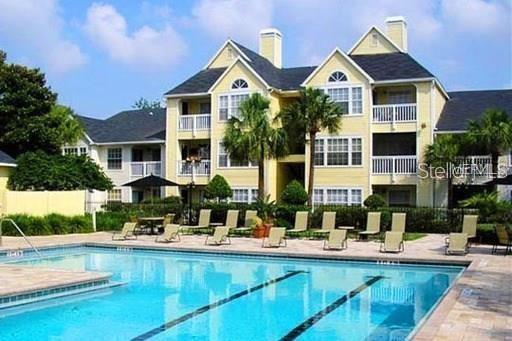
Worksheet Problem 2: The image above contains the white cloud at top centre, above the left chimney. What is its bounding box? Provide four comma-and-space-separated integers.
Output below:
192, 0, 273, 44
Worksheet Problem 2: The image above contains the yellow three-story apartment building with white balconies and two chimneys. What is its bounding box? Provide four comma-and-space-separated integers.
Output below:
164, 17, 512, 206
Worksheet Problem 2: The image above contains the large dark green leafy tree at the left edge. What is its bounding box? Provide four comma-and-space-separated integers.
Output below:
0, 51, 83, 156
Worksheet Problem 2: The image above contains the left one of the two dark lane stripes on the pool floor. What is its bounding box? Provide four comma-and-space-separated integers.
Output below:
132, 270, 306, 341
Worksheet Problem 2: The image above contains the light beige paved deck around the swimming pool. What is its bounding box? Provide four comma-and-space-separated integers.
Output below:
0, 232, 512, 341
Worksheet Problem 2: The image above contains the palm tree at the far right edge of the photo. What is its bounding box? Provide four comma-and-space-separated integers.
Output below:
468, 109, 512, 179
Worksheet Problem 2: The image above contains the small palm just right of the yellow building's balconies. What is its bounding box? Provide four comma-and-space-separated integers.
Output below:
425, 135, 460, 208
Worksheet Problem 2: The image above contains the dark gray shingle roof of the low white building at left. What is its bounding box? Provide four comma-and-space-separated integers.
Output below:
78, 108, 166, 143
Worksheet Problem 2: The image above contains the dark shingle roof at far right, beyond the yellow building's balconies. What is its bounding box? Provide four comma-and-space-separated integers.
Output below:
436, 89, 512, 131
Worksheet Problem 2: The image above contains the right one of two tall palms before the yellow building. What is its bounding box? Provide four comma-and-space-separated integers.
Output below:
278, 88, 343, 205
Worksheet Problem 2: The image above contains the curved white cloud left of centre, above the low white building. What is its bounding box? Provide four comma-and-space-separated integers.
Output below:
84, 3, 187, 69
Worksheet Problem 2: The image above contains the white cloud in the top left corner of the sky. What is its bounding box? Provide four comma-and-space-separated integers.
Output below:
0, 0, 86, 73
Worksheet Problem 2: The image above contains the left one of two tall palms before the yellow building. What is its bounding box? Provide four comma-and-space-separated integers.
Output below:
222, 93, 288, 199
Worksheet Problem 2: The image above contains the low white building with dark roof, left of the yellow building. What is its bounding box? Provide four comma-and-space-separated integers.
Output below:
66, 108, 166, 206
